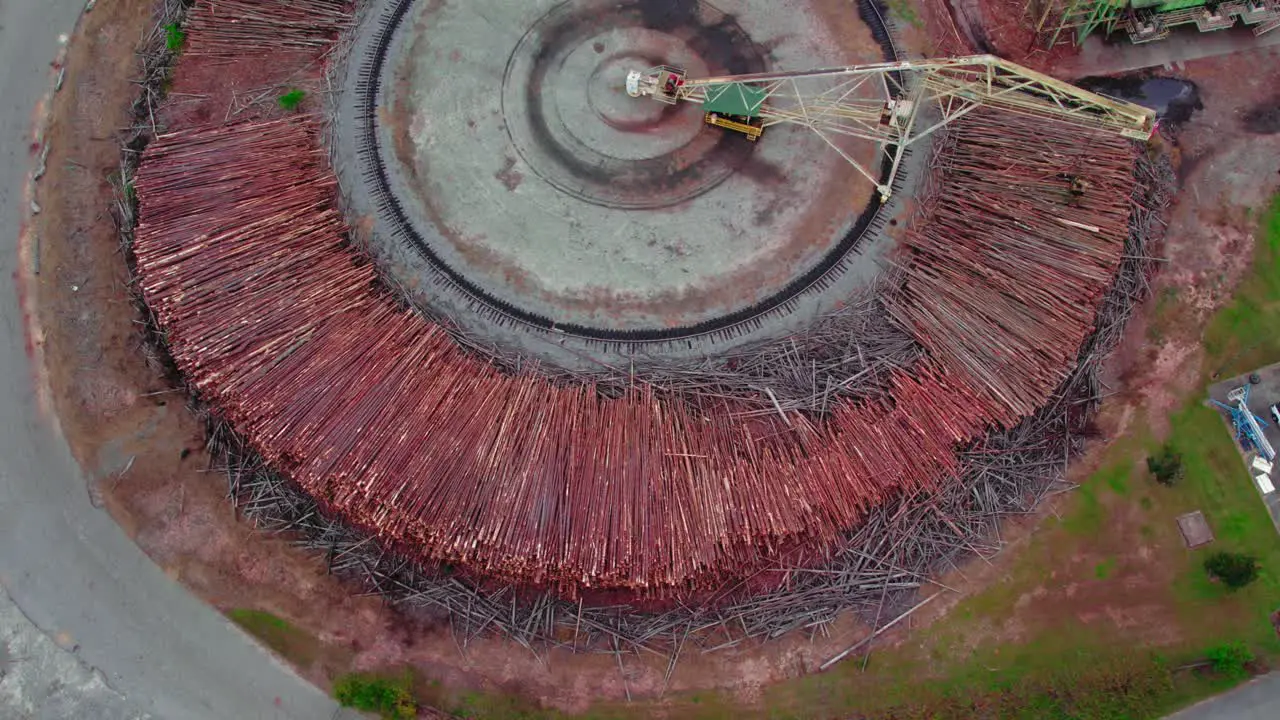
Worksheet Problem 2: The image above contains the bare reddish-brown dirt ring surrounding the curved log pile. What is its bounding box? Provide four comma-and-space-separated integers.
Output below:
27, 0, 1280, 710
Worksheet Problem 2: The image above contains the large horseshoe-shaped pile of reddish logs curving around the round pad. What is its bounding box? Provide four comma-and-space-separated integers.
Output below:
127, 113, 1133, 597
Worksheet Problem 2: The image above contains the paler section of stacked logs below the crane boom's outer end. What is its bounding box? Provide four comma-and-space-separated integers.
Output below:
888, 111, 1134, 427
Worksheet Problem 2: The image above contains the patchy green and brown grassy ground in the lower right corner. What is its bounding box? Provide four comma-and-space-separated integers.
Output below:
373, 197, 1280, 720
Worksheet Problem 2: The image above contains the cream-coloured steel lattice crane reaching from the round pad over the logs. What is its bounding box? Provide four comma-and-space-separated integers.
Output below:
627, 55, 1156, 199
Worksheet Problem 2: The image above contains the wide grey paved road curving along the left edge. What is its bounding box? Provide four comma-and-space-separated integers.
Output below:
0, 0, 337, 720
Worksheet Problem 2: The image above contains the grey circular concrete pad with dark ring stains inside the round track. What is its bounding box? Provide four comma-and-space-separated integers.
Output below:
345, 0, 883, 334
